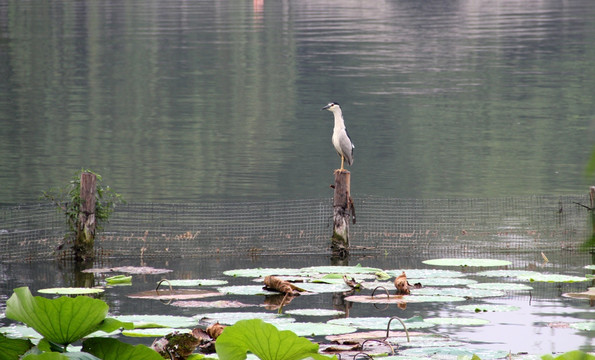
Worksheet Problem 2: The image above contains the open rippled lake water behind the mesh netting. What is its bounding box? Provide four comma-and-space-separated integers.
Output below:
0, 0, 595, 203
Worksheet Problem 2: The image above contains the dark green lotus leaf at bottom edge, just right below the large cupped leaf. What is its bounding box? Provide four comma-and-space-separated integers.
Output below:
83, 338, 163, 360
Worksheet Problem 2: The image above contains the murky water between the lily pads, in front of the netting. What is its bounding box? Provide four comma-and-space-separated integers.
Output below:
0, 252, 595, 355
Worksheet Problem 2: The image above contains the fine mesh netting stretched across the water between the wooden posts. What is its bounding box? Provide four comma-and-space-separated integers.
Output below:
0, 195, 592, 260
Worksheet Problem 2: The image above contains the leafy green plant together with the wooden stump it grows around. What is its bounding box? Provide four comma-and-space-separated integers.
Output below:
42, 169, 124, 261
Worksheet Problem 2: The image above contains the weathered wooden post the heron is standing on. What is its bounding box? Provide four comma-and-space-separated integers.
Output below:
331, 170, 351, 258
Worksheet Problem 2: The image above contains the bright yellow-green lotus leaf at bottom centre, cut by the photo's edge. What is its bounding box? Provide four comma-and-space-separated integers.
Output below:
215, 319, 336, 360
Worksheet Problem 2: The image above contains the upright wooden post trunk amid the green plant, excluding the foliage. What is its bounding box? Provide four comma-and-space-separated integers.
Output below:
74, 172, 97, 261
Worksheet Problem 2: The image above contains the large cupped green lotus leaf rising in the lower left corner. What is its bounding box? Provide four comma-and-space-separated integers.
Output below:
6, 287, 108, 345
